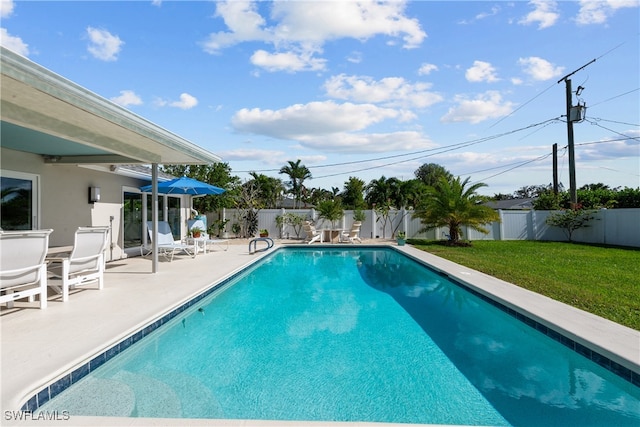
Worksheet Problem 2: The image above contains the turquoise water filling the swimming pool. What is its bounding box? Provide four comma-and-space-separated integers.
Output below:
40, 248, 640, 426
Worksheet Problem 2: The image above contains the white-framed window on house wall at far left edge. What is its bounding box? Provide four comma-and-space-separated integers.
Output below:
0, 170, 40, 230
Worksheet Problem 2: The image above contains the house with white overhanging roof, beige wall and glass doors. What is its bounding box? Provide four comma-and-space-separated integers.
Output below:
0, 47, 221, 260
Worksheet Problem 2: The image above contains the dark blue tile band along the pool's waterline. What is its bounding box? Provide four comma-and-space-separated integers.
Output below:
21, 245, 640, 412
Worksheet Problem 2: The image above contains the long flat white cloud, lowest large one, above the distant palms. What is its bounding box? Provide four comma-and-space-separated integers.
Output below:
231, 101, 404, 140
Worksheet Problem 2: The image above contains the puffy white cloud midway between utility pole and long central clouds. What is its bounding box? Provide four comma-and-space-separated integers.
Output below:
440, 91, 514, 124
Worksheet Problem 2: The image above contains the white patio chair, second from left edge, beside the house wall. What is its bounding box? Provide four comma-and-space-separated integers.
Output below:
48, 227, 109, 302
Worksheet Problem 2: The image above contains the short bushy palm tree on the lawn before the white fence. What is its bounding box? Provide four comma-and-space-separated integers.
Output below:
413, 177, 500, 244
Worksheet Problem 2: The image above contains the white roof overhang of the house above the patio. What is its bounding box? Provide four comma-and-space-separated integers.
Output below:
0, 47, 221, 164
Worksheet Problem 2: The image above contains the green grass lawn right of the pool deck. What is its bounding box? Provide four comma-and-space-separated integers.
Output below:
408, 239, 640, 330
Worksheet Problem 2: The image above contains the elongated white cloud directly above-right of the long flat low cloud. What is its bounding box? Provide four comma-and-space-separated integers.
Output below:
324, 74, 443, 108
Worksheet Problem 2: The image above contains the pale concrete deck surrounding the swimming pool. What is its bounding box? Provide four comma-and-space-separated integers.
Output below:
0, 240, 640, 426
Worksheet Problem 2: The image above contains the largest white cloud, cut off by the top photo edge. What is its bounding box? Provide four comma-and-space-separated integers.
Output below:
203, 0, 426, 71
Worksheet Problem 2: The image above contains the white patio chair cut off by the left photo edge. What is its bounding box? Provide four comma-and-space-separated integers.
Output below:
0, 230, 53, 308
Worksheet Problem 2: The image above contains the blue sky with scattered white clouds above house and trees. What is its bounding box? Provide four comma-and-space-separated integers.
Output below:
0, 0, 640, 195
